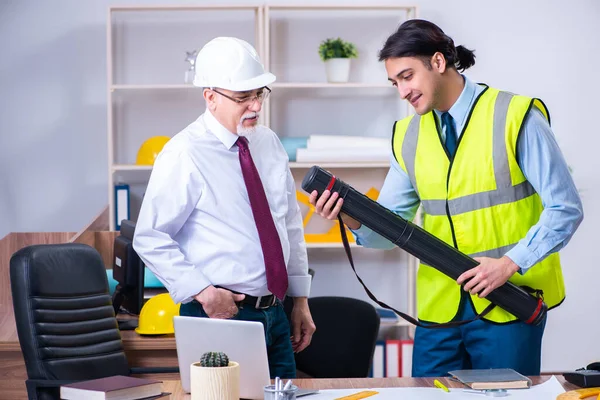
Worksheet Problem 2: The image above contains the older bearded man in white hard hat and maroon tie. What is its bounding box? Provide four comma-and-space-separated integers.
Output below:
134, 37, 315, 378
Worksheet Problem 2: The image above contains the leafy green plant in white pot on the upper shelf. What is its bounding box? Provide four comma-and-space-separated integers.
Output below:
319, 38, 358, 83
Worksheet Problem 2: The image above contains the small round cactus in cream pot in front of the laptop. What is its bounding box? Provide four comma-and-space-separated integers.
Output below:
190, 351, 240, 400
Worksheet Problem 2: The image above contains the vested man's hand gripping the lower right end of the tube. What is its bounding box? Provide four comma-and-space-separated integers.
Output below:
456, 256, 519, 298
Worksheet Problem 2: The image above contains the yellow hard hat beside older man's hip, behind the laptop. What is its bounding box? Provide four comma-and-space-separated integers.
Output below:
135, 293, 181, 335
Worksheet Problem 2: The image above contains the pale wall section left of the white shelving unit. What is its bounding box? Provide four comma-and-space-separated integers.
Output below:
0, 1, 107, 231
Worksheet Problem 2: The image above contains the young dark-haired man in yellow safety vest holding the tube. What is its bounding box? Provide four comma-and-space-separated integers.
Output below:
311, 20, 583, 376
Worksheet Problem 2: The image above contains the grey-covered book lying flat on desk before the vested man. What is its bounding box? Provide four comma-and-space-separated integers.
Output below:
448, 368, 531, 390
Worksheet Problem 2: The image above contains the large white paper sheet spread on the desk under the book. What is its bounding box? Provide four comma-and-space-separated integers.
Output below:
301, 376, 565, 400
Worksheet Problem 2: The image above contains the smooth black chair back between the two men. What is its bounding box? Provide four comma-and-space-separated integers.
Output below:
284, 297, 380, 378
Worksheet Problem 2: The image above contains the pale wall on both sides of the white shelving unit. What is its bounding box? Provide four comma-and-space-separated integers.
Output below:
0, 0, 600, 371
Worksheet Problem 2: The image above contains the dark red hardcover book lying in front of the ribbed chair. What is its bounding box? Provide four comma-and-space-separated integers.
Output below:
60, 375, 162, 400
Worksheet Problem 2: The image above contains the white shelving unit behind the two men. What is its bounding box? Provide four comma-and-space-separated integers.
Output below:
107, 3, 418, 327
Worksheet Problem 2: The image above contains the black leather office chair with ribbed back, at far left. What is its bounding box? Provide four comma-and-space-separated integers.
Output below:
10, 243, 179, 400
